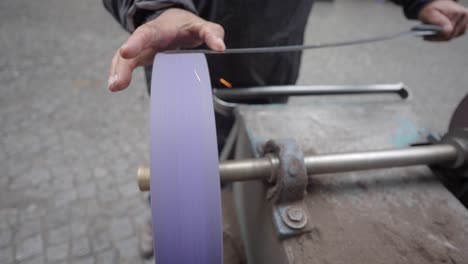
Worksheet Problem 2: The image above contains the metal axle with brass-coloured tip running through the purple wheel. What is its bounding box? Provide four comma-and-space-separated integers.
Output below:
138, 144, 458, 191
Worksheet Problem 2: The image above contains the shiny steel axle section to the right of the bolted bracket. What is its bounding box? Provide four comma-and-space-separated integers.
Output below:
304, 144, 457, 175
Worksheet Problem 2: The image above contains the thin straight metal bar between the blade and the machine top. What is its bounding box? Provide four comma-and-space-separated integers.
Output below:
213, 83, 409, 101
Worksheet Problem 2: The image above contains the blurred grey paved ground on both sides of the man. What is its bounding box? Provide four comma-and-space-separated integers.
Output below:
0, 0, 468, 264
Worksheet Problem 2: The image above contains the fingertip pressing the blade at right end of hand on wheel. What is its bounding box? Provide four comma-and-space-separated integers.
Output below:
195, 22, 226, 51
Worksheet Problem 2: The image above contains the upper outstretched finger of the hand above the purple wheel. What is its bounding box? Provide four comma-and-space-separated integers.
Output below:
120, 24, 158, 59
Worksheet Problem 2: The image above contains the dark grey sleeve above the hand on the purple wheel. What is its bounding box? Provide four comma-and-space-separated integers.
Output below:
103, 0, 197, 32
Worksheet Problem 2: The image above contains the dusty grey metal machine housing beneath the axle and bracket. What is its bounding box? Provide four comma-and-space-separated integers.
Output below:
234, 96, 468, 263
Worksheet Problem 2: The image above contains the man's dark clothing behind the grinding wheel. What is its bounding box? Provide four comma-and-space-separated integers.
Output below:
103, 0, 431, 152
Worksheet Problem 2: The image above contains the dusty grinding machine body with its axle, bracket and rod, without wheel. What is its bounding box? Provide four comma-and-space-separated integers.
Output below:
139, 89, 468, 263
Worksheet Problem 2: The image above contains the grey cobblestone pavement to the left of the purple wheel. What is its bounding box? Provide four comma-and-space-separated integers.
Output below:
0, 0, 149, 264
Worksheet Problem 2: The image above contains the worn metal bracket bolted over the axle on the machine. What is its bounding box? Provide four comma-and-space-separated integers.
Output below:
260, 139, 312, 239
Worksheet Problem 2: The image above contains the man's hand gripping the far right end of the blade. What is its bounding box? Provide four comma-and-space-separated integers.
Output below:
419, 0, 468, 41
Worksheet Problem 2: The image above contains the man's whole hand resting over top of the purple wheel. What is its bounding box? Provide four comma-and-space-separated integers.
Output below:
108, 8, 226, 92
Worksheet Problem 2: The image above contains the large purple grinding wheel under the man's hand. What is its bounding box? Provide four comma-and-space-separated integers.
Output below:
150, 54, 223, 264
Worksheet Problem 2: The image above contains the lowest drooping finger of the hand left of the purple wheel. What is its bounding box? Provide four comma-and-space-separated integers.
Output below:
107, 50, 137, 92
